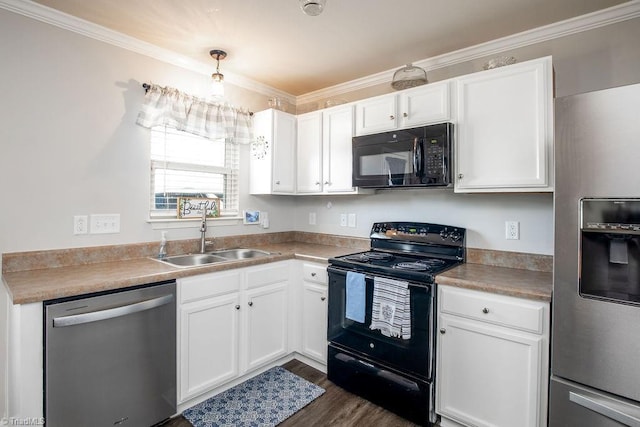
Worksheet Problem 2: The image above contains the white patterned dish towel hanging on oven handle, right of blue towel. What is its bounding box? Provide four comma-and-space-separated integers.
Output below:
370, 277, 411, 340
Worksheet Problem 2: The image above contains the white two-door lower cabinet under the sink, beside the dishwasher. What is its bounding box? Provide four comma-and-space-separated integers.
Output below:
178, 261, 290, 403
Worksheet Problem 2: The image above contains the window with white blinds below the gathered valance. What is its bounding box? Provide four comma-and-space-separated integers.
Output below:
150, 126, 239, 219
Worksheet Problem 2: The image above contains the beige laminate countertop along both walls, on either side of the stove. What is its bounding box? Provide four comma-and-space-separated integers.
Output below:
2, 242, 551, 304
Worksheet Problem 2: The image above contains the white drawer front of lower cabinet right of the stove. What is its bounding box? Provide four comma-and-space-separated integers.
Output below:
438, 286, 546, 334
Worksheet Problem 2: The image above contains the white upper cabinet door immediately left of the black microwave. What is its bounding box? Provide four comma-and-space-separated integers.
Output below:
322, 105, 354, 193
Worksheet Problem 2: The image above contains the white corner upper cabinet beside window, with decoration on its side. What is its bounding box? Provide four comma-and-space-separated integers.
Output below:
249, 109, 296, 194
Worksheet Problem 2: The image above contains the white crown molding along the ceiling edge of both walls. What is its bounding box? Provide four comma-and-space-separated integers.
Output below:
0, 0, 640, 105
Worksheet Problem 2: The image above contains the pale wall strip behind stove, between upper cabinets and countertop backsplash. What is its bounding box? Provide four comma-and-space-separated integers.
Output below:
295, 189, 553, 255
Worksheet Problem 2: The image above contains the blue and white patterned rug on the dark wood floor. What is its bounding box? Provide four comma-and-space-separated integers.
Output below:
182, 366, 324, 427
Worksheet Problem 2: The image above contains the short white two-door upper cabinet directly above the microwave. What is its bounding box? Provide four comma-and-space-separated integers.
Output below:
355, 81, 451, 136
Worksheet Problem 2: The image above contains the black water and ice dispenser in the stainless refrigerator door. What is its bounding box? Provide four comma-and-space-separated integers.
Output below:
580, 198, 640, 304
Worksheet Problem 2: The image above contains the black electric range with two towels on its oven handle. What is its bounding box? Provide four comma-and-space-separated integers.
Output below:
327, 222, 466, 425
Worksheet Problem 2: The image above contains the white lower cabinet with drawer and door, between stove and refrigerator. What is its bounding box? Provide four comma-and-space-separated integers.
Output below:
436, 286, 549, 427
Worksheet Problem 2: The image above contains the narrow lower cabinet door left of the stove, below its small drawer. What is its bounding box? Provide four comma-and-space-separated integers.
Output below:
302, 282, 327, 363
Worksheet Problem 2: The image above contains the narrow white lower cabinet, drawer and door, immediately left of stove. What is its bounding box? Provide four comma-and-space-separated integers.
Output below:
301, 263, 328, 364
